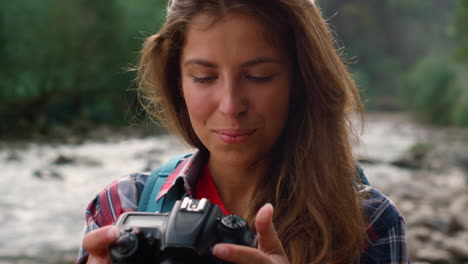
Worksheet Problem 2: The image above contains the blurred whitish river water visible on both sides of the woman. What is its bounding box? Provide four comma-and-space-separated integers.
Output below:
0, 114, 466, 264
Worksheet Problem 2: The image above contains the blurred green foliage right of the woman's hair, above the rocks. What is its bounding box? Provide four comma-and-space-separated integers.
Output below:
318, 0, 468, 125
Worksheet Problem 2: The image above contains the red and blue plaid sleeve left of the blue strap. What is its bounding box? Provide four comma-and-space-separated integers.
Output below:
76, 173, 149, 264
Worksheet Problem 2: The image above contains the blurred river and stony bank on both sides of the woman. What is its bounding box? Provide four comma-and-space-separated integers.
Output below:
0, 113, 468, 264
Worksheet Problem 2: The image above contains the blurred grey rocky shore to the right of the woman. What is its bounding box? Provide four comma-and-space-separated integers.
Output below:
354, 112, 468, 263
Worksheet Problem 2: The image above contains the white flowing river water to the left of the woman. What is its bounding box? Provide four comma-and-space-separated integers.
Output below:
0, 136, 193, 264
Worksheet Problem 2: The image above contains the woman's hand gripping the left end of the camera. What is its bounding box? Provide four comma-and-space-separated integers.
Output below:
83, 225, 120, 264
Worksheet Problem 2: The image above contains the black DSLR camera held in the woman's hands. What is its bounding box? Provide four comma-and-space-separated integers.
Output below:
109, 198, 257, 264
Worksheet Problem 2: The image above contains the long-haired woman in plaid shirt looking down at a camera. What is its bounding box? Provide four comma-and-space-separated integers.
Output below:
78, 0, 408, 263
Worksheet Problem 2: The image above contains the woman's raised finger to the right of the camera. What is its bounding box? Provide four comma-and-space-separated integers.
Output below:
255, 203, 286, 256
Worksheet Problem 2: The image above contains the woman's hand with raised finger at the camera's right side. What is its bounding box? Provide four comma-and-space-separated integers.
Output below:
213, 204, 289, 264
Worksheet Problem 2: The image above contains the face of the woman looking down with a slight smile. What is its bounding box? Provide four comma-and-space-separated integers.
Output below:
180, 14, 291, 166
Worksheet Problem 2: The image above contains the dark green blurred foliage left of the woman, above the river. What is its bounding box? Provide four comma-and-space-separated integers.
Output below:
0, 0, 164, 135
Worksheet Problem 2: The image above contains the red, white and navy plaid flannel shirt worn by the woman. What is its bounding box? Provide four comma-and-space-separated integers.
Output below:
76, 152, 409, 264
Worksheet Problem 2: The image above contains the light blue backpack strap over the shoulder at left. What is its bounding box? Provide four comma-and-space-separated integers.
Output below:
137, 154, 191, 212
